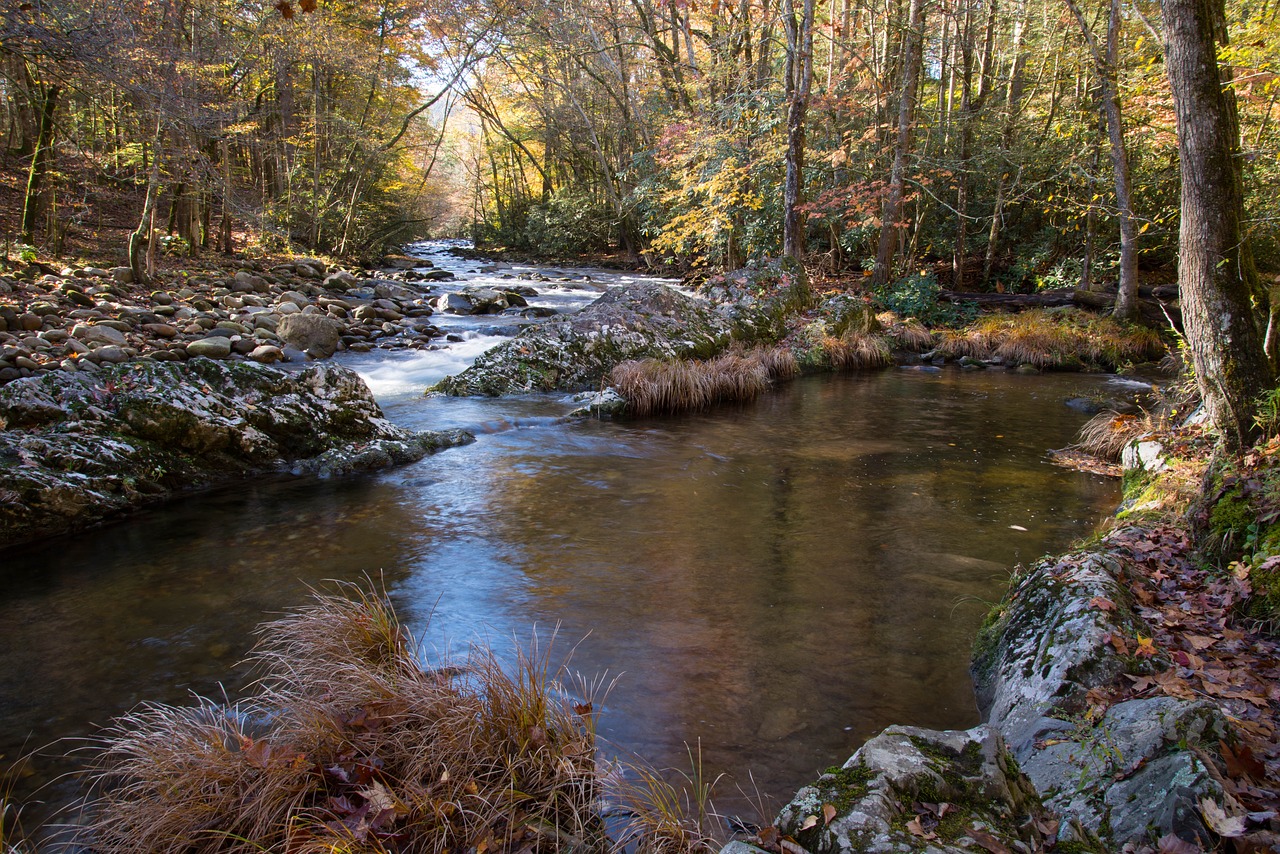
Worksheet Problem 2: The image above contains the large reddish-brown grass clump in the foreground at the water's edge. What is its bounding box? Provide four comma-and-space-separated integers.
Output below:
82, 585, 605, 854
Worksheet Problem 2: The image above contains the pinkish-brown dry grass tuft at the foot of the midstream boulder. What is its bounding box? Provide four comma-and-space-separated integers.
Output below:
609, 347, 799, 416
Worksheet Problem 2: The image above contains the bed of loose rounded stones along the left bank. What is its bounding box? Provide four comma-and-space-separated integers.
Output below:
0, 253, 453, 384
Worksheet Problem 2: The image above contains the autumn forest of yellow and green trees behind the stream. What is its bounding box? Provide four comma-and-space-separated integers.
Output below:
0, 0, 1280, 291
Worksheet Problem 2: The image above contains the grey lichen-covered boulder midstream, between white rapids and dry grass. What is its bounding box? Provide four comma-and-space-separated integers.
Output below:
429, 283, 733, 396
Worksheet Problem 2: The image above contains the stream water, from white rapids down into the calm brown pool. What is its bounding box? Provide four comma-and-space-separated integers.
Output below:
0, 243, 1119, 839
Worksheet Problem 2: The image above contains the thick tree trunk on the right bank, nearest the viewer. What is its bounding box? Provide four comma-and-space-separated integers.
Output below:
1162, 0, 1272, 448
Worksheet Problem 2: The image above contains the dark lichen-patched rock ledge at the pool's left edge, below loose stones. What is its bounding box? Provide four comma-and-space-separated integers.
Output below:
0, 359, 471, 544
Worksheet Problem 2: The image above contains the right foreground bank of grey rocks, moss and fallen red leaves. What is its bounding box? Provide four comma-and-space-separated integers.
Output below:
742, 424, 1280, 853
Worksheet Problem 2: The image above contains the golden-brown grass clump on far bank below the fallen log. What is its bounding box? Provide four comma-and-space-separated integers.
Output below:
938, 310, 1166, 369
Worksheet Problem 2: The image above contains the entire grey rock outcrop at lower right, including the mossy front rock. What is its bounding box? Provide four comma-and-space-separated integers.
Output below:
758, 540, 1228, 854
